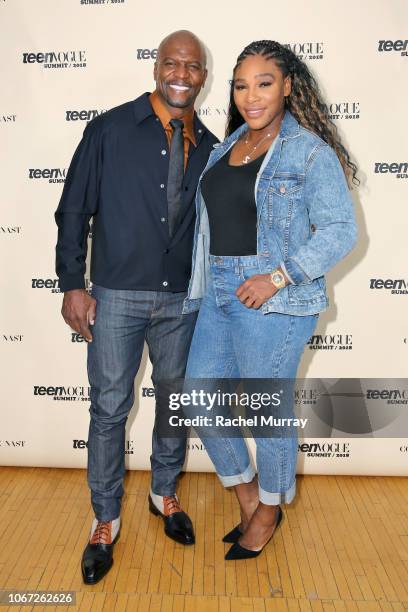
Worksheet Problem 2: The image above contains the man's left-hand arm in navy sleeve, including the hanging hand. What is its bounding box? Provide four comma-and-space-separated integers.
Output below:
55, 122, 102, 342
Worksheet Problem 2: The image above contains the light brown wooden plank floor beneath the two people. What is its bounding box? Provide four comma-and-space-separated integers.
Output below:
0, 467, 408, 612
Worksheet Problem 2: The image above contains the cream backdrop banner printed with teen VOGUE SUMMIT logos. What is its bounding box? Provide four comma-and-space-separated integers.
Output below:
0, 0, 408, 475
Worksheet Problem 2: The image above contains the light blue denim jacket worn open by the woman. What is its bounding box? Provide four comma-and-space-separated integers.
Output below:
183, 111, 357, 315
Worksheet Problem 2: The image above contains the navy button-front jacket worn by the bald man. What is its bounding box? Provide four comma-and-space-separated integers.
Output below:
55, 93, 218, 292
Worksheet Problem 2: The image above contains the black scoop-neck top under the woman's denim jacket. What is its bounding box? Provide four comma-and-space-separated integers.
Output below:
201, 152, 266, 256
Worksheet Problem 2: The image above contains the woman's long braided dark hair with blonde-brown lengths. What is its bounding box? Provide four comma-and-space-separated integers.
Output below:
226, 40, 360, 184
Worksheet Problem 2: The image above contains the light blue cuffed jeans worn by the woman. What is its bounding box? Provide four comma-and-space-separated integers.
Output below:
186, 255, 318, 505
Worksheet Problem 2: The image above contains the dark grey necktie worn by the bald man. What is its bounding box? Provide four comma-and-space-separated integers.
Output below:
167, 119, 184, 236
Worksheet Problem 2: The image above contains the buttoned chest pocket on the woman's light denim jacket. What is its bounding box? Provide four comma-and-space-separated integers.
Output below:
268, 175, 303, 228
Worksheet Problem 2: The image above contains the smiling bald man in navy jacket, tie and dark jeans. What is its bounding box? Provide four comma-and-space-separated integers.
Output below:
55, 30, 217, 584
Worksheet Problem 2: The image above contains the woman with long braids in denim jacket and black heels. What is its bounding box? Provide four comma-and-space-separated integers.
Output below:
184, 41, 358, 559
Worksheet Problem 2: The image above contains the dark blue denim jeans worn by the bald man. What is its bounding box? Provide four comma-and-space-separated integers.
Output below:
88, 285, 196, 521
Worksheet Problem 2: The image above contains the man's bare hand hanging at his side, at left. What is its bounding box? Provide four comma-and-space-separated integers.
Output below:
61, 289, 96, 342
